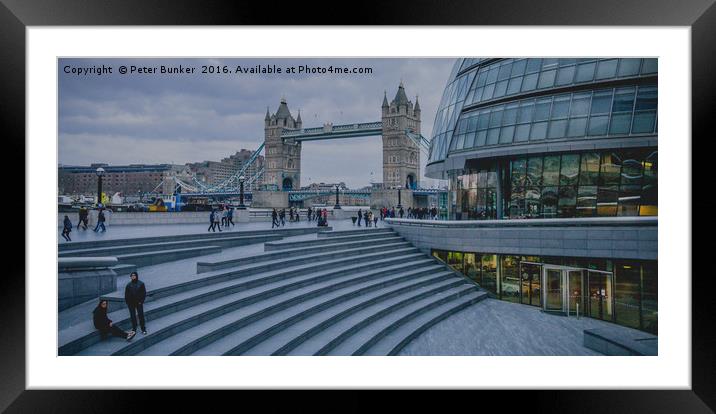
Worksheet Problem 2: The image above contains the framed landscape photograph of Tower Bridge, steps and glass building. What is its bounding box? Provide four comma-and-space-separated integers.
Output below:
57, 54, 670, 358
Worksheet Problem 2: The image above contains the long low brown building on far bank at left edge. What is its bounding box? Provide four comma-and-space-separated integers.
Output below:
57, 163, 190, 196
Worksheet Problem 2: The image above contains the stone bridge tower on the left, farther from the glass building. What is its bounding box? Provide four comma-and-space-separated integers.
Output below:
263, 98, 302, 191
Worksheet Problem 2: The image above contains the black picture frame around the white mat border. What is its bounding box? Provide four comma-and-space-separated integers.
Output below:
0, 0, 716, 413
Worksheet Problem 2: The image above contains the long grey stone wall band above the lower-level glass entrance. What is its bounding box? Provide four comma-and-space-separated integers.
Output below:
386, 217, 658, 260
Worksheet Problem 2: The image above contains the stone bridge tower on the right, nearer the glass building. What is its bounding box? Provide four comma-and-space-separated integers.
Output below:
382, 81, 420, 189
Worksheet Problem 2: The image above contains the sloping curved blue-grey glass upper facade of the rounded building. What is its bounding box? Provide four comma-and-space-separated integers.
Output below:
428, 58, 658, 163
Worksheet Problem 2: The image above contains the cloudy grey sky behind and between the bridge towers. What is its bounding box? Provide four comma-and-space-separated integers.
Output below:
58, 58, 454, 188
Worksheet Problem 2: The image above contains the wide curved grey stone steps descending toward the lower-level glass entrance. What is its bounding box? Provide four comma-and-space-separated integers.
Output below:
59, 228, 486, 355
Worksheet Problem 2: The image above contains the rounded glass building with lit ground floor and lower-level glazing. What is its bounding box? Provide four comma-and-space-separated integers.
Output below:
426, 58, 658, 333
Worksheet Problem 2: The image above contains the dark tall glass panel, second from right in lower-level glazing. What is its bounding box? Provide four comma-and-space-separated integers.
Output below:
614, 262, 641, 329
